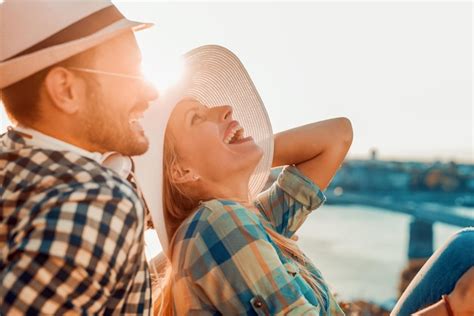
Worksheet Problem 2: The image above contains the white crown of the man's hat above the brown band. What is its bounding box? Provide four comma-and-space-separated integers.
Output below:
0, 0, 113, 61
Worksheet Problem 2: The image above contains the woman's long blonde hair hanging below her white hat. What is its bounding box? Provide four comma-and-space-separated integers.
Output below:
152, 133, 324, 316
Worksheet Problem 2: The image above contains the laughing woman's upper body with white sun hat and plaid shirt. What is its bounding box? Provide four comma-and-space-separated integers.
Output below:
143, 46, 472, 315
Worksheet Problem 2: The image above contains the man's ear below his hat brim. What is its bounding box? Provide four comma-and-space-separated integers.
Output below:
44, 67, 86, 114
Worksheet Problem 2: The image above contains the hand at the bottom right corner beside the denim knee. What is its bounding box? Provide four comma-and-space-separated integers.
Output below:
449, 267, 474, 315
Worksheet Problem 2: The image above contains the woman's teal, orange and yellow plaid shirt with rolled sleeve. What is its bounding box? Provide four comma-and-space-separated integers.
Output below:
172, 166, 344, 315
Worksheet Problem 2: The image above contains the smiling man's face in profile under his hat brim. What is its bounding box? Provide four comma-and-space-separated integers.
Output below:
80, 32, 158, 156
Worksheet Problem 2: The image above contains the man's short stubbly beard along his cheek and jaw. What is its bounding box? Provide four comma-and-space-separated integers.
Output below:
82, 86, 148, 156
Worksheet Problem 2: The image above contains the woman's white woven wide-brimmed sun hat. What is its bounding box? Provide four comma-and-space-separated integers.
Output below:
136, 45, 273, 251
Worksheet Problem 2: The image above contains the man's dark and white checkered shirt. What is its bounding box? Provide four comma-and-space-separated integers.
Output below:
0, 131, 151, 315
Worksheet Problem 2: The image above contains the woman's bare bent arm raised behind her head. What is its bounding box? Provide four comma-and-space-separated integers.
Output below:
273, 117, 352, 190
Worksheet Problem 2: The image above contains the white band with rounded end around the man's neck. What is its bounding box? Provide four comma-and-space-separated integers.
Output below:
13, 125, 133, 178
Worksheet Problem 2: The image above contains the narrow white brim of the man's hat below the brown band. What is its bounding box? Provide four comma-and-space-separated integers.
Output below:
0, 18, 153, 89
